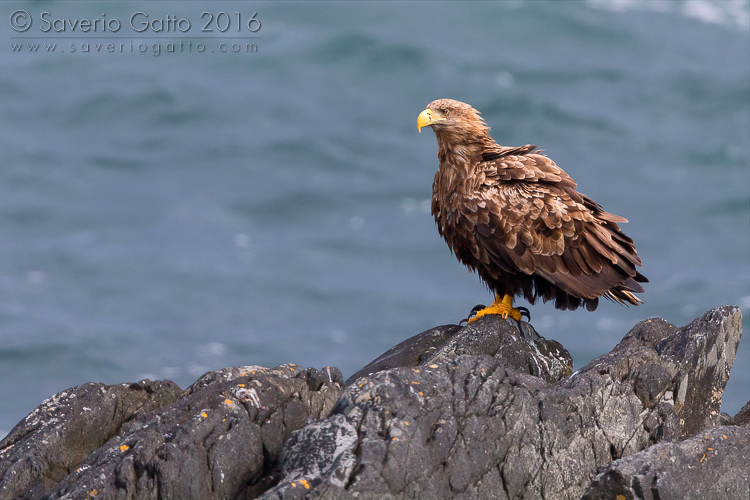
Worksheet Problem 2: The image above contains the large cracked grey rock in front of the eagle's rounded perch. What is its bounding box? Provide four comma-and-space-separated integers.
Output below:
262, 307, 741, 499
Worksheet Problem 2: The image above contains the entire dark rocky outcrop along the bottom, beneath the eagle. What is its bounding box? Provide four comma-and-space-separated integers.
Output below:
0, 306, 750, 500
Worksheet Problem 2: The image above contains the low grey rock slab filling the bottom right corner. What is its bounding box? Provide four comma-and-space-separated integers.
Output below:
583, 425, 750, 500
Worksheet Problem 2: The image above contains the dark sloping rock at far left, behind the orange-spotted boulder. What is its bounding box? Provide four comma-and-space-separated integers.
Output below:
0, 380, 182, 499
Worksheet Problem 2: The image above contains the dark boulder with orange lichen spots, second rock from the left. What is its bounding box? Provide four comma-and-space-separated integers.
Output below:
3, 365, 343, 499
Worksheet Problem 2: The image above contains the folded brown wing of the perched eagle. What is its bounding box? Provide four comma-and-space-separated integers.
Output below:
465, 146, 645, 300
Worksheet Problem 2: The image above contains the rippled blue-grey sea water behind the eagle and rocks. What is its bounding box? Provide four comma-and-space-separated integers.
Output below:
0, 0, 750, 436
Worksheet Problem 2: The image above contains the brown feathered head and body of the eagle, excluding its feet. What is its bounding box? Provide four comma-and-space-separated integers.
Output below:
417, 99, 648, 311
